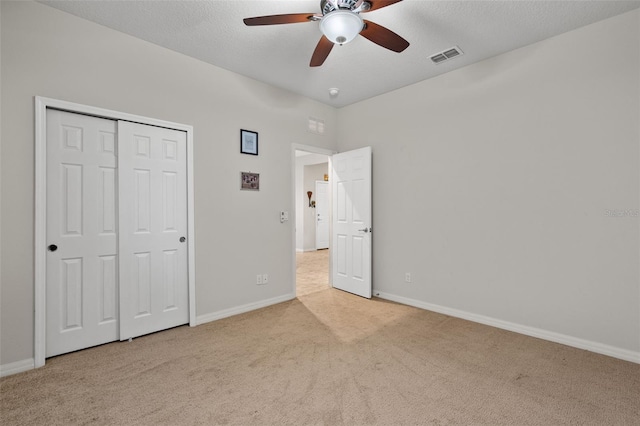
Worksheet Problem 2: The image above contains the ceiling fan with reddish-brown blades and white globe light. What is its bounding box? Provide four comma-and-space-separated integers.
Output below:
244, 0, 409, 67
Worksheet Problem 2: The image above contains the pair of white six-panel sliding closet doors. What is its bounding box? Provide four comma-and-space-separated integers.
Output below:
45, 108, 189, 357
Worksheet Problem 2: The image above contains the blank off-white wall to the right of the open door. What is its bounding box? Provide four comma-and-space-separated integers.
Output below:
338, 10, 640, 362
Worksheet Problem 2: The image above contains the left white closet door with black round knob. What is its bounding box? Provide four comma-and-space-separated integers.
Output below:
45, 109, 119, 357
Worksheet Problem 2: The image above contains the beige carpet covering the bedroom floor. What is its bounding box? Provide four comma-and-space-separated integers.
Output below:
0, 255, 640, 425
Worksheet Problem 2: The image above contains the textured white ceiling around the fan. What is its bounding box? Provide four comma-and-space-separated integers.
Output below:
41, 0, 640, 107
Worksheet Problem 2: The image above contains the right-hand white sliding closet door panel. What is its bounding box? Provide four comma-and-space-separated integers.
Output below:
118, 121, 189, 340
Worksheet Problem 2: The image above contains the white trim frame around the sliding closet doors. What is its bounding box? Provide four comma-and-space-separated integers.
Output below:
34, 96, 196, 368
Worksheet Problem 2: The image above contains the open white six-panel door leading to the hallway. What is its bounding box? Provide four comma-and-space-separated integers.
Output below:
331, 147, 371, 298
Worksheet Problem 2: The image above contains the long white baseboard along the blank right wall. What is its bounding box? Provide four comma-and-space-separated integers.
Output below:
373, 290, 640, 364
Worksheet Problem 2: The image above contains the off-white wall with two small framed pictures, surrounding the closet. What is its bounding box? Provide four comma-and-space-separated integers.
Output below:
0, 1, 336, 365
